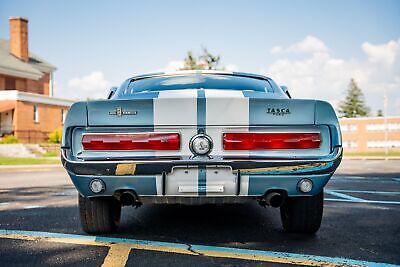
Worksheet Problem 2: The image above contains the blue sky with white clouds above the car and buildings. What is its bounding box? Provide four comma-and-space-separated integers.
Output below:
0, 0, 400, 115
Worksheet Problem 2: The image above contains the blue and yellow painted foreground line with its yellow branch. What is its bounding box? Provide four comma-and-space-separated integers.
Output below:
0, 229, 400, 267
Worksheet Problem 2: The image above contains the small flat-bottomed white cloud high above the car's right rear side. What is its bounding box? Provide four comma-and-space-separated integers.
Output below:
270, 35, 328, 54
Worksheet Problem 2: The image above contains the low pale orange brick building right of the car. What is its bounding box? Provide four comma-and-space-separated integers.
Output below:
340, 117, 400, 152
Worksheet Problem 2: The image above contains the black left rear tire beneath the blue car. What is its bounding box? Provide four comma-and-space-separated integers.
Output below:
79, 195, 121, 234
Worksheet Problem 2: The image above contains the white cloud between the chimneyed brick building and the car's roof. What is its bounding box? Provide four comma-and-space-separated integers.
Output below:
66, 71, 110, 99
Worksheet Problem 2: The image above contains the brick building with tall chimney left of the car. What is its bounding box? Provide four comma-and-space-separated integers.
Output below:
0, 17, 72, 143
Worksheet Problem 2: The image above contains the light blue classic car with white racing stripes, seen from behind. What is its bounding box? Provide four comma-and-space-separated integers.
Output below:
62, 71, 342, 233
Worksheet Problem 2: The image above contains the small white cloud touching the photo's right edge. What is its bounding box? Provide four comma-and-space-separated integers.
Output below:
361, 39, 400, 65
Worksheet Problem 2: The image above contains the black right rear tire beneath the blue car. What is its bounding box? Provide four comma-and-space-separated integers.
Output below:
281, 191, 324, 234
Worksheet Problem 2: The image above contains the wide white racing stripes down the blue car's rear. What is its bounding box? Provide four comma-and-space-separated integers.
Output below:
154, 90, 249, 195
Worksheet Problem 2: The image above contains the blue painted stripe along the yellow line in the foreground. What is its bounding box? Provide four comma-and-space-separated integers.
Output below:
0, 229, 400, 267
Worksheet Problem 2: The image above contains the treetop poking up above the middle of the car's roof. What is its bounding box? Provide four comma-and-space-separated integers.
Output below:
181, 48, 223, 70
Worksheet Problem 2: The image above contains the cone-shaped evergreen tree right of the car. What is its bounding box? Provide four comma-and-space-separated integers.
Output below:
339, 79, 369, 118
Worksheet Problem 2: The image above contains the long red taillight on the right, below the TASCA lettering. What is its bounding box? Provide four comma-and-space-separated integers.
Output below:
223, 133, 321, 150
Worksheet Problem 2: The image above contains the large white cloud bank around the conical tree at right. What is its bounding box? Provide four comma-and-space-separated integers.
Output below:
262, 36, 400, 115
